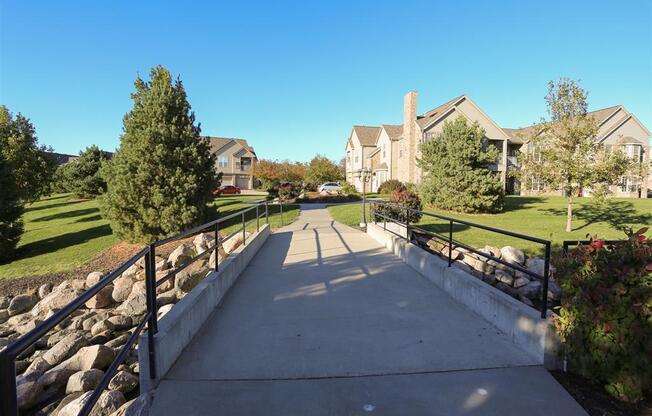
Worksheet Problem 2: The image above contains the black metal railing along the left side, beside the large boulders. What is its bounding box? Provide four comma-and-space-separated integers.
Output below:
0, 202, 283, 416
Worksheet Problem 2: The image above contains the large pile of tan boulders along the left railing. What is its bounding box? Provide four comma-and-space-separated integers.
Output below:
0, 233, 250, 416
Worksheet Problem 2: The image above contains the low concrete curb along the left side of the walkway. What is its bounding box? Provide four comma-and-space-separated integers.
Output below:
138, 224, 271, 393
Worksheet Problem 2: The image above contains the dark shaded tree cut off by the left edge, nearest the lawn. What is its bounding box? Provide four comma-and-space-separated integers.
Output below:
0, 152, 23, 263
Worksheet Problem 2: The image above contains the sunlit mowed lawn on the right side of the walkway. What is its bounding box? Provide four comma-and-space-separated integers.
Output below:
328, 196, 652, 255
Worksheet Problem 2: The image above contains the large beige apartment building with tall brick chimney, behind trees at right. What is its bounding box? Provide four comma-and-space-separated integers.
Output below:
345, 91, 652, 198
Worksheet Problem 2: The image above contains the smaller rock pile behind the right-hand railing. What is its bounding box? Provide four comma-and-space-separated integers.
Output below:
416, 236, 561, 307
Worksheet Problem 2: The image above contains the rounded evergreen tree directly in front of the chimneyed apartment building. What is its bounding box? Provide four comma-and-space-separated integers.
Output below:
417, 116, 504, 213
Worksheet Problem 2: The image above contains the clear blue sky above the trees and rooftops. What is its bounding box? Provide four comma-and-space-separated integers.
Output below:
0, 0, 652, 160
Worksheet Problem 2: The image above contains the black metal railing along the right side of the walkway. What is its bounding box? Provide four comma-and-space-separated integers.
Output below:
371, 201, 551, 319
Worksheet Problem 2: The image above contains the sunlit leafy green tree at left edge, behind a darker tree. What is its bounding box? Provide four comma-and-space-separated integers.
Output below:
0, 106, 56, 202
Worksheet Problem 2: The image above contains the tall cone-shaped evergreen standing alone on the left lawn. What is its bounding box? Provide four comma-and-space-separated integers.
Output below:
102, 66, 217, 243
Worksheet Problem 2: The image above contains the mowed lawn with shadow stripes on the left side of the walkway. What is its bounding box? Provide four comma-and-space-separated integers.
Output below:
0, 194, 299, 278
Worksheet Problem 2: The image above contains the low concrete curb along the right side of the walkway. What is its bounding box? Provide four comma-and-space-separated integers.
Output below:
367, 223, 561, 369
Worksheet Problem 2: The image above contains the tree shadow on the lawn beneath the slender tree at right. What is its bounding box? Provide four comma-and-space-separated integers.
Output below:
545, 200, 652, 231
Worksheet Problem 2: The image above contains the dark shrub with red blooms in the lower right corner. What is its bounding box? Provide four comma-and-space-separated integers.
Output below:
555, 228, 652, 402
